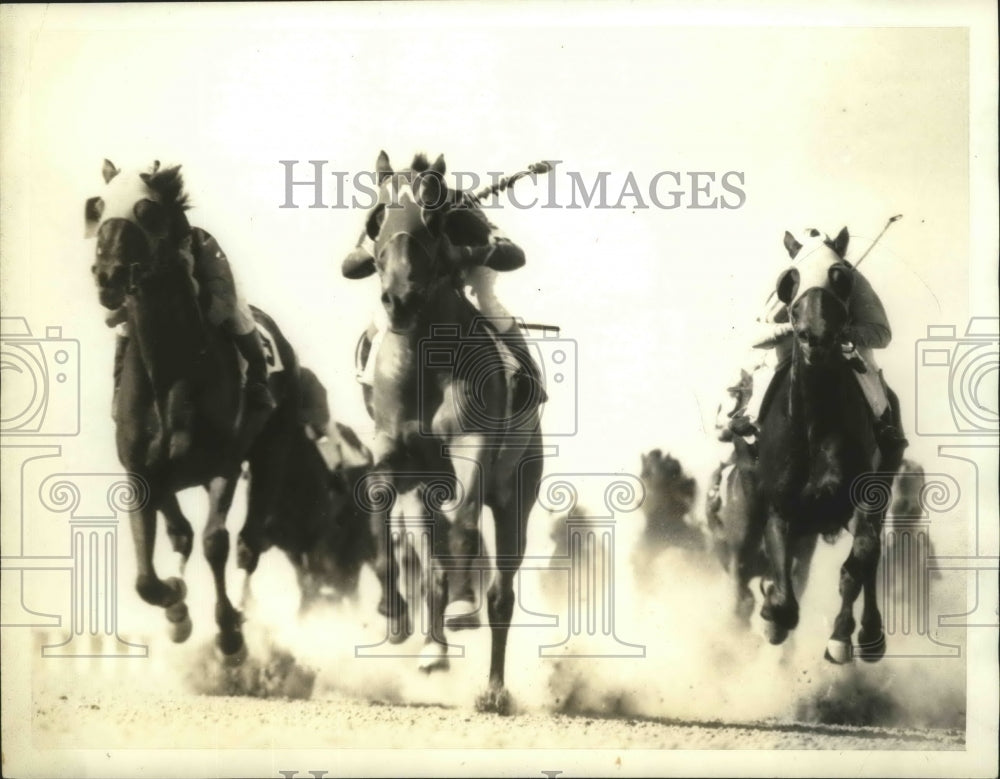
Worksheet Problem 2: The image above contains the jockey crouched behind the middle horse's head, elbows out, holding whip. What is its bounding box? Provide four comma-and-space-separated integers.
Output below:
341, 198, 548, 409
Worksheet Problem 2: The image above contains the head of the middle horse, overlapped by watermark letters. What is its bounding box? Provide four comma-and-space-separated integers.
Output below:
343, 151, 507, 332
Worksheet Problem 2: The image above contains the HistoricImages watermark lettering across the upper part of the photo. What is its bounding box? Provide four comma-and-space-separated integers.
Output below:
278, 160, 747, 211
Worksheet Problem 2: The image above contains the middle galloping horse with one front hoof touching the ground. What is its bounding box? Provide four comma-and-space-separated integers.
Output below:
344, 152, 542, 712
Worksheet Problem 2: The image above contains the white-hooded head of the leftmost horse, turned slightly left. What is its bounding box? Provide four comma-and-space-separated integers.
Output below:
84, 160, 190, 310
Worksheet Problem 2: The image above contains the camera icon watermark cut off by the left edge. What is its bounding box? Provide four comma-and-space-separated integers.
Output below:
0, 317, 80, 436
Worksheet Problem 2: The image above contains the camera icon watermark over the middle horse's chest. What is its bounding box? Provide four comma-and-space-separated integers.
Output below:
418, 317, 578, 437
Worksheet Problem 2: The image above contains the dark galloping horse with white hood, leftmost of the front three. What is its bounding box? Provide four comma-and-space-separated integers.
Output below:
86, 160, 298, 662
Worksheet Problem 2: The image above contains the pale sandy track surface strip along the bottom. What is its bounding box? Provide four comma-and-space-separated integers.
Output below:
33, 689, 964, 750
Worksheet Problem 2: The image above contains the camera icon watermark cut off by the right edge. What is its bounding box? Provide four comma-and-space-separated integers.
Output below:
915, 317, 1000, 436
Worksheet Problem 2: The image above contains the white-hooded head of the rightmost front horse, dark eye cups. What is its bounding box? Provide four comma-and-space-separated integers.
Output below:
777, 227, 854, 365
